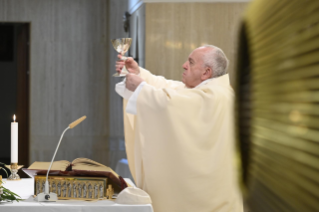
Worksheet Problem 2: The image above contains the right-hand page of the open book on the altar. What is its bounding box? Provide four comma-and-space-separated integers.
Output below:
72, 158, 118, 177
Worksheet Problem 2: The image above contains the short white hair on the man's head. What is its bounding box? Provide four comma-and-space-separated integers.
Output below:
202, 45, 229, 78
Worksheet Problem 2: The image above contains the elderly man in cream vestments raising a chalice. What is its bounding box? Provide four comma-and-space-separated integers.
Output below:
116, 46, 243, 212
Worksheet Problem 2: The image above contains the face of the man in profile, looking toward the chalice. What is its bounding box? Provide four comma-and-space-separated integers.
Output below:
182, 47, 207, 88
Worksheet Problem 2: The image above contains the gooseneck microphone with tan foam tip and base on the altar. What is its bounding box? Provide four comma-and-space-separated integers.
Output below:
35, 116, 86, 202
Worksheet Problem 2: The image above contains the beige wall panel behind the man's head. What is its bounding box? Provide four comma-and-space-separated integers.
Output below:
145, 3, 247, 82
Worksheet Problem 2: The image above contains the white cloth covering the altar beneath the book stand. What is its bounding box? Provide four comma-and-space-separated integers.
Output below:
0, 178, 153, 212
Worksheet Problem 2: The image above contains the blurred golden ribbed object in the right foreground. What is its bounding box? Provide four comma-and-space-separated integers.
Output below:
235, 0, 319, 212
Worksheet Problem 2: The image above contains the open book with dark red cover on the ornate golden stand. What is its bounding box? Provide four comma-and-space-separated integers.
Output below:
22, 158, 127, 188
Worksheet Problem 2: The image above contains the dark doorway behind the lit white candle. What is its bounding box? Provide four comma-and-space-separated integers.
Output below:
0, 22, 30, 177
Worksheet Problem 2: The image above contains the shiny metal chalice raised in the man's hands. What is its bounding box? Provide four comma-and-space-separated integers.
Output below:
111, 38, 132, 77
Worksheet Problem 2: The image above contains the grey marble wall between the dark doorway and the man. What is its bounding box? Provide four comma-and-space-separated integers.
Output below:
0, 0, 127, 168
